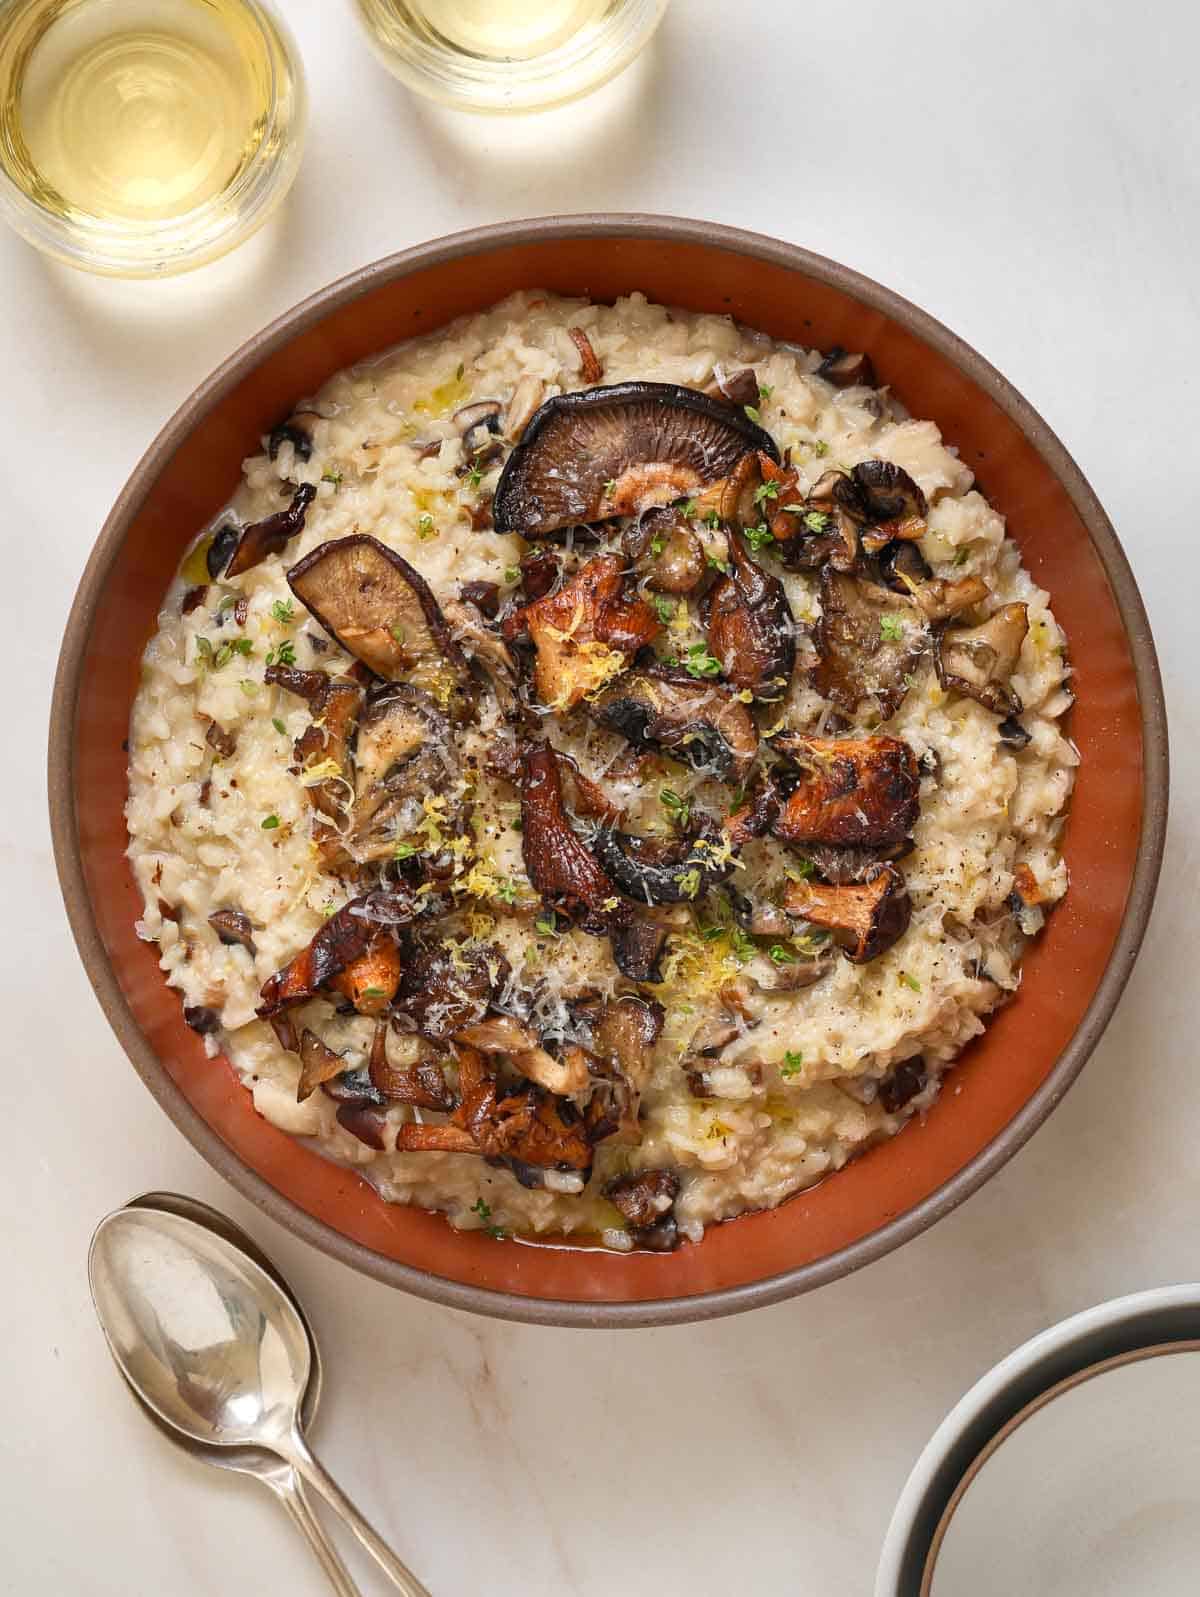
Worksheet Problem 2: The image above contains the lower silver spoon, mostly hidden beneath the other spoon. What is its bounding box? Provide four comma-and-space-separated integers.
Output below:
125, 1191, 361, 1597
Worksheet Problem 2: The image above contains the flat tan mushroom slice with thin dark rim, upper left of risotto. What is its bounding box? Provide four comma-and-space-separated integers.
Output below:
288, 533, 467, 685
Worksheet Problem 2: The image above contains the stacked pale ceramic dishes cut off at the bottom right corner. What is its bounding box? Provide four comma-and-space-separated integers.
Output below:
876, 1282, 1200, 1597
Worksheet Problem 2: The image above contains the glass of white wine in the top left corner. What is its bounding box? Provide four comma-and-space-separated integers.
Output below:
0, 0, 307, 278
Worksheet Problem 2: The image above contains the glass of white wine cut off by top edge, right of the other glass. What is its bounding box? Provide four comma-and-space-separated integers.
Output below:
356, 0, 668, 112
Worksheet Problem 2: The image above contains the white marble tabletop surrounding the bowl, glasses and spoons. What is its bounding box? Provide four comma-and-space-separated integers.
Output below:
0, 0, 1200, 1597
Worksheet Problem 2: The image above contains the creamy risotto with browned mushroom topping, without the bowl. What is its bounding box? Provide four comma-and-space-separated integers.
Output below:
128, 294, 1077, 1249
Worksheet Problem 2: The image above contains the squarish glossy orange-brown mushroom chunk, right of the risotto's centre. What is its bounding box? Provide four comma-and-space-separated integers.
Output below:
772, 731, 920, 848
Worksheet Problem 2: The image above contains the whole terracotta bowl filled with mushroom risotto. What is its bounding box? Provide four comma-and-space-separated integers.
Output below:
50, 217, 1166, 1326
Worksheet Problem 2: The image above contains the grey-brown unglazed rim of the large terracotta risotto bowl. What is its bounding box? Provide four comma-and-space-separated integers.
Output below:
48, 212, 1170, 1329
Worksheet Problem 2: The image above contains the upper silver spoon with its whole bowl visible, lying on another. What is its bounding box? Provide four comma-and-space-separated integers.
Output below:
88, 1207, 430, 1597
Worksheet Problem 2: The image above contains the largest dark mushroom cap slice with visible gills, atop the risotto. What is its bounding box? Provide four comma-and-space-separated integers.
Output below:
494, 383, 778, 538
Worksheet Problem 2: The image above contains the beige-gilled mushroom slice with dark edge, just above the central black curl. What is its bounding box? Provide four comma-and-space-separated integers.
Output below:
591, 666, 759, 783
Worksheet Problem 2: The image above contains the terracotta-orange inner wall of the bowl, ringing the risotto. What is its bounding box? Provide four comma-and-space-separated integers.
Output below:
51, 224, 1152, 1319
